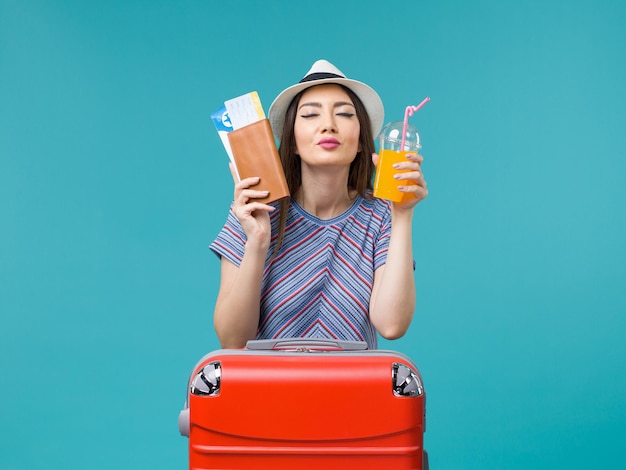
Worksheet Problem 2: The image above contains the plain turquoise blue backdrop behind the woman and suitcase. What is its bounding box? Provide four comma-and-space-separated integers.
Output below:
0, 0, 626, 470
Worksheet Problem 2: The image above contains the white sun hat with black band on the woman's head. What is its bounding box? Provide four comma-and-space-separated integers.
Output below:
268, 59, 385, 140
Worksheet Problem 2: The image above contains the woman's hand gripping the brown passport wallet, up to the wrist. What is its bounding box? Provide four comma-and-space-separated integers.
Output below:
228, 163, 276, 249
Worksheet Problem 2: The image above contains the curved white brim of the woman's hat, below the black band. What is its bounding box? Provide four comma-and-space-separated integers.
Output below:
268, 77, 385, 141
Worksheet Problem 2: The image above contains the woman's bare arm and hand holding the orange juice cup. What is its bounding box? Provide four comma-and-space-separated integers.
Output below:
370, 154, 428, 339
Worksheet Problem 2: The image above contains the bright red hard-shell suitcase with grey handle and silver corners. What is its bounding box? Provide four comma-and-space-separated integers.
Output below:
179, 339, 428, 470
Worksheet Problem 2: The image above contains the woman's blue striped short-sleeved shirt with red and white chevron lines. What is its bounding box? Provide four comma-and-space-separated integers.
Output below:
210, 196, 391, 349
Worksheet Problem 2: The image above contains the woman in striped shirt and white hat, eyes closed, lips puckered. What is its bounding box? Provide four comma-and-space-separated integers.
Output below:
211, 60, 427, 348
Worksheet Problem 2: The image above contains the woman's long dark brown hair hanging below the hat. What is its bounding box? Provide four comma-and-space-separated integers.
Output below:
274, 84, 375, 255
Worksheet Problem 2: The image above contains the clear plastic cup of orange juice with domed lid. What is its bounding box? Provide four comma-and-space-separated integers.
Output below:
374, 121, 421, 202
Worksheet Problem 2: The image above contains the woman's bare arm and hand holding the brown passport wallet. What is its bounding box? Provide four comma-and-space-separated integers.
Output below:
213, 163, 274, 348
